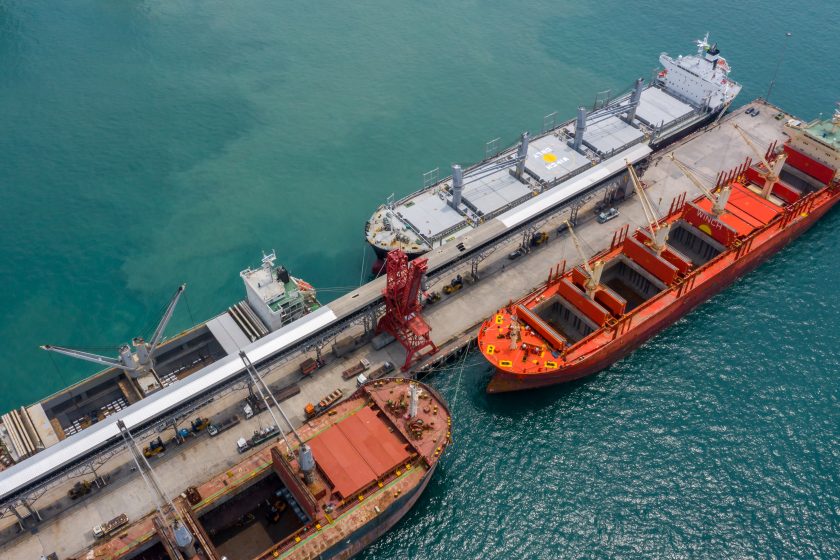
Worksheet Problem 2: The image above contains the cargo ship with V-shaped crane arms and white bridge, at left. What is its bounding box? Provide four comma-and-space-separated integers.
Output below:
0, 251, 320, 471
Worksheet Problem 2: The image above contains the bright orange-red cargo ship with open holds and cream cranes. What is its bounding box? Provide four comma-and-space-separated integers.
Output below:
478, 108, 840, 393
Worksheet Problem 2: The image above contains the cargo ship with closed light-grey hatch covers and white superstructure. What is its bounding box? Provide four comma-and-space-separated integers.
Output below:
365, 34, 741, 260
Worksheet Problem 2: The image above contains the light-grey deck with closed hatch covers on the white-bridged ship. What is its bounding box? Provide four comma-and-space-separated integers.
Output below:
367, 80, 703, 253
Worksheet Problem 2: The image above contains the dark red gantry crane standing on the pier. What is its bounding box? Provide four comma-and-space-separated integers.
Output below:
376, 249, 437, 371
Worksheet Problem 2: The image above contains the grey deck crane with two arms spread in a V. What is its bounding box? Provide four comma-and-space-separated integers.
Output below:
41, 284, 187, 383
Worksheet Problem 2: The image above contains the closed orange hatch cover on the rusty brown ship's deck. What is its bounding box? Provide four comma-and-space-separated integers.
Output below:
308, 406, 410, 498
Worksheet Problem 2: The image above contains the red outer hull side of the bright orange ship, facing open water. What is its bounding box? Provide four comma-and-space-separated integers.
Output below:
487, 193, 840, 393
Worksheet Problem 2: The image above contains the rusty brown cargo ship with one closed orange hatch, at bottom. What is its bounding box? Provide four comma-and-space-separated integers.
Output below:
76, 378, 451, 560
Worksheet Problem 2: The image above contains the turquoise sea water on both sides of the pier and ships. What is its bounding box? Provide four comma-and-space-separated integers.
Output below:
0, 0, 840, 559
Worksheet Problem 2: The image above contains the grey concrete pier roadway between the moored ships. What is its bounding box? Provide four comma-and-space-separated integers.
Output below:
0, 102, 796, 560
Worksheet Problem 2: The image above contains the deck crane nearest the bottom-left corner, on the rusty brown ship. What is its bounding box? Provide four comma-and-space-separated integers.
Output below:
117, 420, 196, 560
